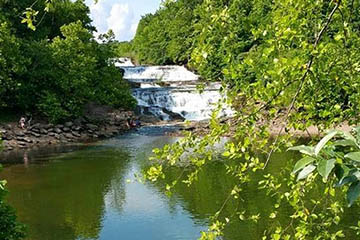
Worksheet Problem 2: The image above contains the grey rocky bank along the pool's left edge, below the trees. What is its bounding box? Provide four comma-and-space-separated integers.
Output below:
0, 110, 134, 152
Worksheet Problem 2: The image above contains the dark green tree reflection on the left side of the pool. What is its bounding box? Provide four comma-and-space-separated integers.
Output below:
2, 148, 129, 239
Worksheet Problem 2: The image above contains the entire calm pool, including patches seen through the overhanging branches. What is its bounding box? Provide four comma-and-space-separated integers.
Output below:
0, 128, 358, 240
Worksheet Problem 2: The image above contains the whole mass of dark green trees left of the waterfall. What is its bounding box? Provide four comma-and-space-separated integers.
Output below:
0, 0, 135, 122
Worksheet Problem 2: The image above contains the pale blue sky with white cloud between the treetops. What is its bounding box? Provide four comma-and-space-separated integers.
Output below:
85, 0, 161, 41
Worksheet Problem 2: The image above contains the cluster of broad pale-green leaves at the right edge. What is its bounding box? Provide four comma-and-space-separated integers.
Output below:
289, 127, 360, 206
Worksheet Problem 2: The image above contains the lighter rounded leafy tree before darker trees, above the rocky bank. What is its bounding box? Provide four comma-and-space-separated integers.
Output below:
39, 22, 135, 121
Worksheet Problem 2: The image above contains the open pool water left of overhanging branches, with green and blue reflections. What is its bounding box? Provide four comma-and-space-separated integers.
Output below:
0, 129, 205, 240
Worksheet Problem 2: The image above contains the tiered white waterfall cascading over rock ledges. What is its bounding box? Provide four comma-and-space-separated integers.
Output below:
118, 59, 232, 121
